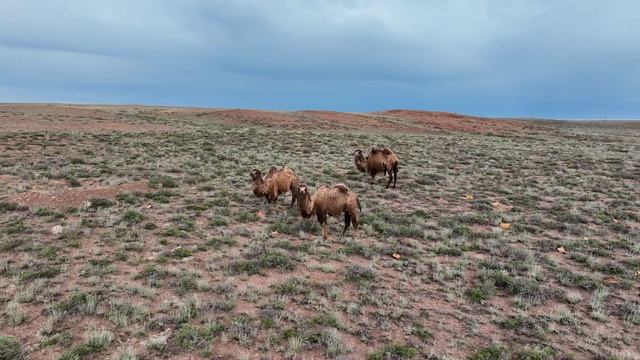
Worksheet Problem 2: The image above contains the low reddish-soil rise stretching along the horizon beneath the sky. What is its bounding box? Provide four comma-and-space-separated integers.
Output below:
0, 104, 544, 135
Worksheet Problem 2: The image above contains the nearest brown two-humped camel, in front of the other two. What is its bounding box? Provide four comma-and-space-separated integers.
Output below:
298, 184, 362, 240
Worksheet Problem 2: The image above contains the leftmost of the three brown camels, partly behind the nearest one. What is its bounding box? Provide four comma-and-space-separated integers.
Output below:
251, 165, 300, 207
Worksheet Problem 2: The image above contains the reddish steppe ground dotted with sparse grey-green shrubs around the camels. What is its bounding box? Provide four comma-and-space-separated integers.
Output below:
0, 104, 640, 359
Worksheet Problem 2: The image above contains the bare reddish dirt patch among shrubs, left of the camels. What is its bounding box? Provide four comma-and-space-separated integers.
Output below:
11, 181, 149, 210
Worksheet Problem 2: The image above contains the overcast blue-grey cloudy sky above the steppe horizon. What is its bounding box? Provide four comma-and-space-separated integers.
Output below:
0, 0, 640, 118
